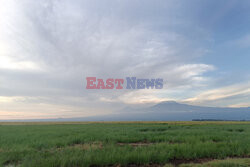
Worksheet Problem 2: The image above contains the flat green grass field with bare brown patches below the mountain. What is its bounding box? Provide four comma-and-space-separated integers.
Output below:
0, 122, 250, 167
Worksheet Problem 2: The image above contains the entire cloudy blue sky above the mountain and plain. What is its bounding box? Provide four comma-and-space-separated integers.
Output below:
0, 0, 250, 120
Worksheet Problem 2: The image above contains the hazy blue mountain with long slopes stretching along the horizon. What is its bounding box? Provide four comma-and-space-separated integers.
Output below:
1, 101, 250, 121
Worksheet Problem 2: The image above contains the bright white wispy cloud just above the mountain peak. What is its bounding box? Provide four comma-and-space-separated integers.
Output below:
100, 64, 214, 104
